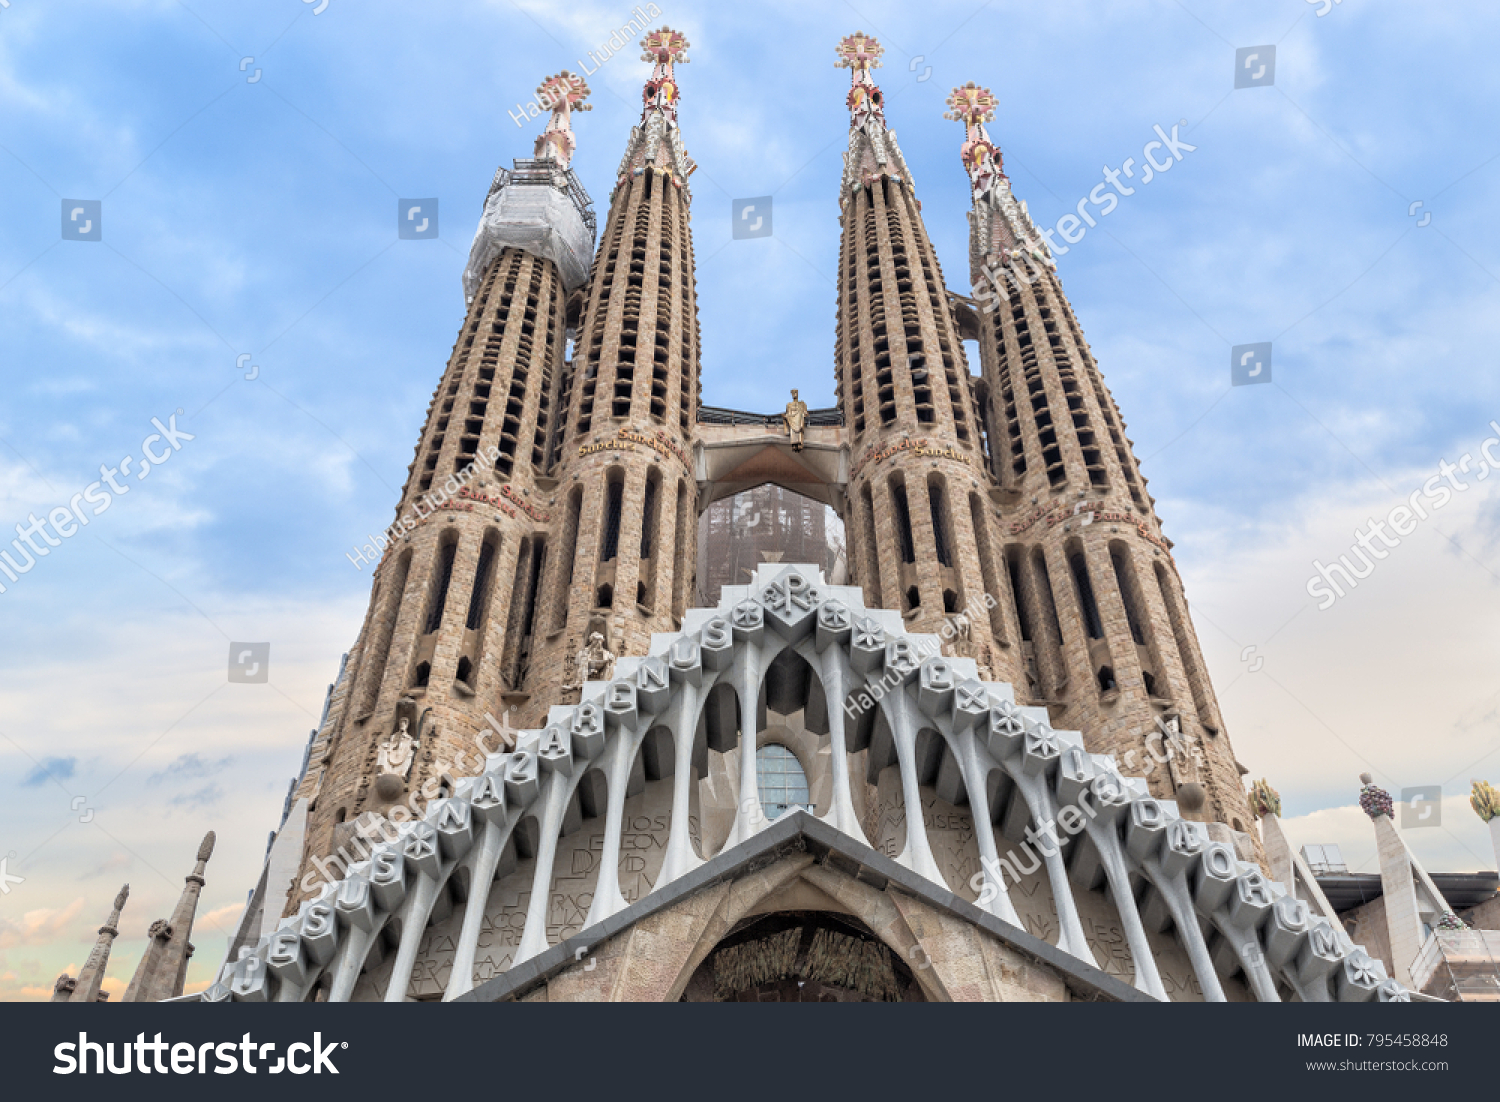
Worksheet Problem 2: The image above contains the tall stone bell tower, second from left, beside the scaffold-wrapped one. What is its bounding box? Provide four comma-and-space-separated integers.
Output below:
522, 27, 699, 724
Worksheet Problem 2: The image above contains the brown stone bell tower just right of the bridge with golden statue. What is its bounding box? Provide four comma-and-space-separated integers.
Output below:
834, 33, 1017, 681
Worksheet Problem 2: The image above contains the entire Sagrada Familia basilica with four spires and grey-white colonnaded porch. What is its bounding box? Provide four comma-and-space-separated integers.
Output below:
59, 27, 1500, 1003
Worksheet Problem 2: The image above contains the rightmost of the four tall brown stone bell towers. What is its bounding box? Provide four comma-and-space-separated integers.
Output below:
947, 81, 1253, 832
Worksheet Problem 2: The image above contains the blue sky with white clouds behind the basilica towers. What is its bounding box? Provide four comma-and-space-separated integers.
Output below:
0, 0, 1500, 999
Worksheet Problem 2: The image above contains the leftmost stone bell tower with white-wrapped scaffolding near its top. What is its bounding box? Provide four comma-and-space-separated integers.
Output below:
293, 70, 594, 899
